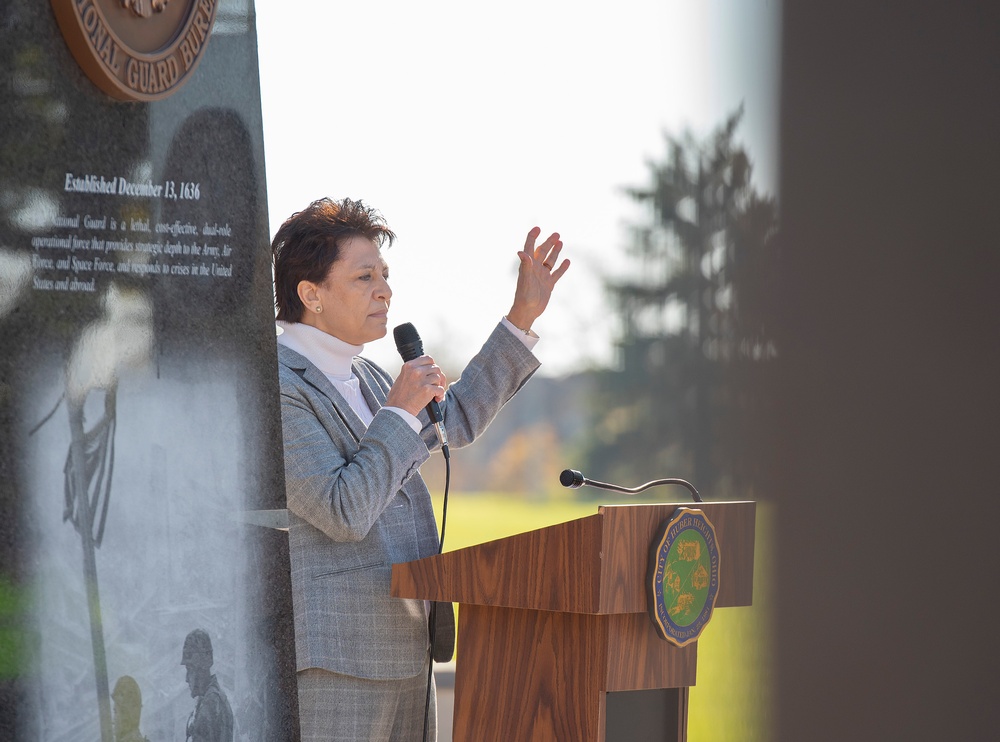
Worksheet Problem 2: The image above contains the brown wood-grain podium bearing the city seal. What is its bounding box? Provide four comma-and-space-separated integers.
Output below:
392, 502, 756, 742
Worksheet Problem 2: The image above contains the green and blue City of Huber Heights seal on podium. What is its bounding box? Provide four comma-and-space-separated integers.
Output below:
646, 508, 719, 647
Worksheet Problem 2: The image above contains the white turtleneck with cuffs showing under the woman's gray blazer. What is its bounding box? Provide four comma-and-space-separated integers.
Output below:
276, 317, 538, 433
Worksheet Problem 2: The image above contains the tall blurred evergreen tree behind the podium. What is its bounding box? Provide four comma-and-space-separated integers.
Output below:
586, 108, 777, 494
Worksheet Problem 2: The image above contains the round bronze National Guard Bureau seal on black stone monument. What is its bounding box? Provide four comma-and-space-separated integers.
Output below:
51, 0, 219, 102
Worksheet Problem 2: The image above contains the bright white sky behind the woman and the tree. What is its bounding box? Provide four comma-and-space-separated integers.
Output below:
256, 0, 780, 375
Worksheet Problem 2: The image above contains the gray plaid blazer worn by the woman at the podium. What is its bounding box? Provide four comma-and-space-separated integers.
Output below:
278, 325, 539, 679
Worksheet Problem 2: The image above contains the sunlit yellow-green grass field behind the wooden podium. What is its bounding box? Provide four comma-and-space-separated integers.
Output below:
435, 493, 772, 742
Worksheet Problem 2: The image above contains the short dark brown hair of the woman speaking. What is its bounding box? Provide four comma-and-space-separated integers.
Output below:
271, 198, 396, 322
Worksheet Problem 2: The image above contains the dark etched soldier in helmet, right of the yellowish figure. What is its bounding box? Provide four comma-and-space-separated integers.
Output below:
181, 629, 233, 742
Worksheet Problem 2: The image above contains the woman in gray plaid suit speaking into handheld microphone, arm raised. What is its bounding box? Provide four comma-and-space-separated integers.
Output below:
271, 199, 569, 742
